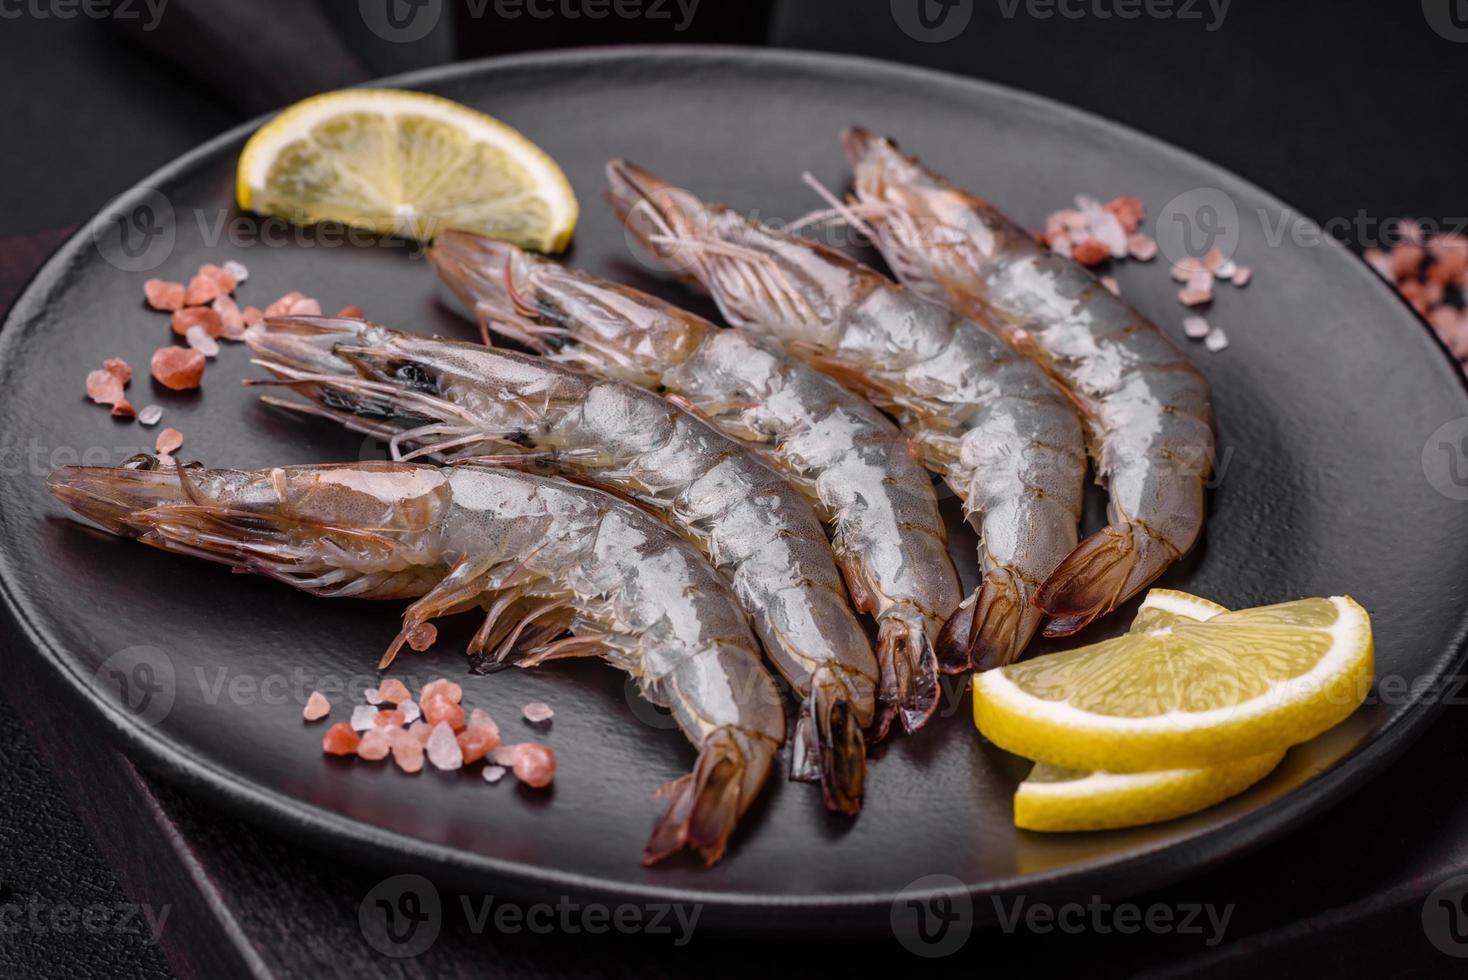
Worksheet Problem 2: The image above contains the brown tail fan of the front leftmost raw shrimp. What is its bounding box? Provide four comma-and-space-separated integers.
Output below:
642, 728, 749, 866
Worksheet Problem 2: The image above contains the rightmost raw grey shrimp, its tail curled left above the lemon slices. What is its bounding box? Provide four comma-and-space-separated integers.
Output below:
843, 126, 1214, 635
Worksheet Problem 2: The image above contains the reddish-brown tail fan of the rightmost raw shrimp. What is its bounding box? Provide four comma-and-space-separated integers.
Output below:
1033, 522, 1180, 637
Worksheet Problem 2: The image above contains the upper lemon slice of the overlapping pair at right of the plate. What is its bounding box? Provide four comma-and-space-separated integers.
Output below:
973, 596, 1374, 773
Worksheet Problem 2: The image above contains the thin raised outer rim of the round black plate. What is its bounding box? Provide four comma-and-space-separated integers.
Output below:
0, 44, 1468, 932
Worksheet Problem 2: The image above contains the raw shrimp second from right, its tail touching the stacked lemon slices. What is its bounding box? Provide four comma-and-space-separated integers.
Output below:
608, 160, 1085, 672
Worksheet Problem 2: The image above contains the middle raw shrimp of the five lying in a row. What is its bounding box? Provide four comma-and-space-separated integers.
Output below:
429, 232, 960, 738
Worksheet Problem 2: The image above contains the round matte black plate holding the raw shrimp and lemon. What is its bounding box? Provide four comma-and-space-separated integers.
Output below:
0, 50, 1468, 927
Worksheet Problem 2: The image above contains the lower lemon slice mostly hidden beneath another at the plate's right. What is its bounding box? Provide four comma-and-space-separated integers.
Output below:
1014, 748, 1285, 830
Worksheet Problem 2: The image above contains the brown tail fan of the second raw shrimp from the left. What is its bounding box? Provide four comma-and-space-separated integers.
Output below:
790, 668, 866, 816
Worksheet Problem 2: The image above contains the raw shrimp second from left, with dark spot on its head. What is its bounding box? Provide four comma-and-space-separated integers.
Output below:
247, 317, 876, 814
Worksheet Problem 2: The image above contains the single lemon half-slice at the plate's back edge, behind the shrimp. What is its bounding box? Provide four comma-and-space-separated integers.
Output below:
235, 88, 578, 252
